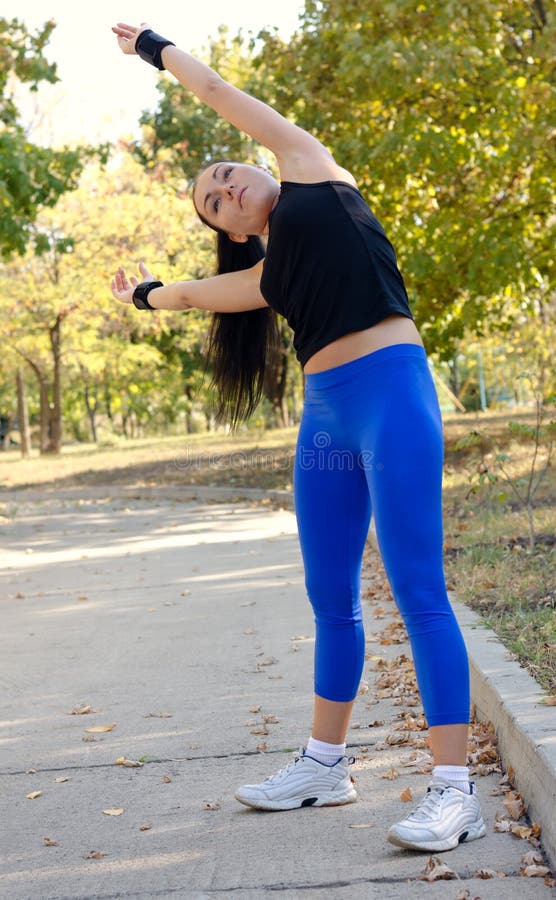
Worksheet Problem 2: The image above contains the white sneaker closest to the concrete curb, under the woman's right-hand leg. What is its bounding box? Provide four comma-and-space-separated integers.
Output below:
387, 778, 486, 853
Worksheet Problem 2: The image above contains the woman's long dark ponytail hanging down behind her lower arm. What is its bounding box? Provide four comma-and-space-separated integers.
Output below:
196, 178, 280, 428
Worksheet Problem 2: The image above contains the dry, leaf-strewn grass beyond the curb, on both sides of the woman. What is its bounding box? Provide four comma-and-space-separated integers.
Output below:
0, 412, 556, 693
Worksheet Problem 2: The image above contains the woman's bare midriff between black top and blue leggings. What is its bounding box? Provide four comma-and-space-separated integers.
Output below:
303, 315, 423, 375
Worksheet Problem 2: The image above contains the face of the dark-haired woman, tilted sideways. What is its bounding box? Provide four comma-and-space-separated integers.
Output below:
193, 162, 280, 240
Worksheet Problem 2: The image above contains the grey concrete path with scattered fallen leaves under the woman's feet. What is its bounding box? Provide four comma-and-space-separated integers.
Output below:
0, 494, 553, 900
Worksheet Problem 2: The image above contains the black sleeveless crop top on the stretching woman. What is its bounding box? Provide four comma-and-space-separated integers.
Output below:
261, 181, 413, 366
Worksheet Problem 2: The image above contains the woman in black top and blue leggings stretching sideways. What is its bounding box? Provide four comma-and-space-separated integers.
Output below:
112, 24, 485, 852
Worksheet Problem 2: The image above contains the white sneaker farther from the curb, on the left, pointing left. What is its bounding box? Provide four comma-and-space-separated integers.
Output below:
235, 747, 357, 810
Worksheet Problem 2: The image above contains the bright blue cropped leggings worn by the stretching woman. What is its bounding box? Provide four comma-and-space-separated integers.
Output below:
294, 344, 470, 726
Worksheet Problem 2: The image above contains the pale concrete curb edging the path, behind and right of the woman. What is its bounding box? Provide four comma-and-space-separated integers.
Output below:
4, 485, 556, 868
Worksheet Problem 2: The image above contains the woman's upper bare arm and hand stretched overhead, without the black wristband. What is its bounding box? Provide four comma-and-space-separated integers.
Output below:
112, 22, 333, 162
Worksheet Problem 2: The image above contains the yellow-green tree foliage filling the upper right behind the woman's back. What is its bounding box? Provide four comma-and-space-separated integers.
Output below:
257, 0, 556, 358
